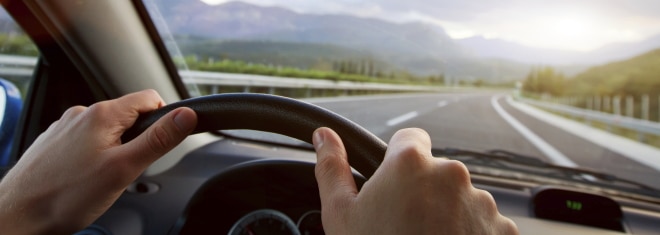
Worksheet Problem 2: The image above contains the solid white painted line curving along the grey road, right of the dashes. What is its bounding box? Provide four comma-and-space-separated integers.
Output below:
490, 96, 577, 167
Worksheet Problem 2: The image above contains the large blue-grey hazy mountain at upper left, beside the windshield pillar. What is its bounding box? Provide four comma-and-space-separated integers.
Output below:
159, 0, 464, 57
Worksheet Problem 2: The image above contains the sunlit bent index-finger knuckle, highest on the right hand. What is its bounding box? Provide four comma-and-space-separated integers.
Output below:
383, 128, 432, 169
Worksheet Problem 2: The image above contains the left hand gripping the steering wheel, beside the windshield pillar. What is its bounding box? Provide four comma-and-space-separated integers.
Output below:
0, 90, 197, 234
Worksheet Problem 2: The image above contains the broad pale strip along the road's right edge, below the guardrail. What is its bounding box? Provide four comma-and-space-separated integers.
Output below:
507, 97, 660, 171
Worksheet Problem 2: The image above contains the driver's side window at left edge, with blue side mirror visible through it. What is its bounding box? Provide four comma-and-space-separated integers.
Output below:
0, 8, 39, 167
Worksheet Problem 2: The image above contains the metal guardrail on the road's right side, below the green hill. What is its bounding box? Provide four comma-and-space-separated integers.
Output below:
516, 97, 660, 136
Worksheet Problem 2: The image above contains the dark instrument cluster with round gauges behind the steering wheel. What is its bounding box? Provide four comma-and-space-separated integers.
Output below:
170, 160, 364, 234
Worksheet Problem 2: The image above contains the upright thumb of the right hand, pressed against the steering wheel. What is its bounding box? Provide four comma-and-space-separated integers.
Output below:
312, 127, 358, 208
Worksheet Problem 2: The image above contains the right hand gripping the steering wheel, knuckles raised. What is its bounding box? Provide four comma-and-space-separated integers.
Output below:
312, 128, 518, 234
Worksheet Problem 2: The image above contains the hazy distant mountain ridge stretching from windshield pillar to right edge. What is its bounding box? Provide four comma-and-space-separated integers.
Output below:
159, 0, 660, 65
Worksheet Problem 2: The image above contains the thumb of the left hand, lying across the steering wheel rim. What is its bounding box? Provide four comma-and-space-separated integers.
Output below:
122, 107, 197, 168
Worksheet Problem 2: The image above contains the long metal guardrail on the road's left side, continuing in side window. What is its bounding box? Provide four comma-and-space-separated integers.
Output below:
0, 54, 447, 91
